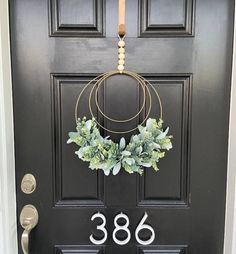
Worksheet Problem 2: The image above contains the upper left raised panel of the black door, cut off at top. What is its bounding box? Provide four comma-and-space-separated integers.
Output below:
49, 0, 105, 37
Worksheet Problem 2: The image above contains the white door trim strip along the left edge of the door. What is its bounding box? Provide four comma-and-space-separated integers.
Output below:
0, 0, 18, 254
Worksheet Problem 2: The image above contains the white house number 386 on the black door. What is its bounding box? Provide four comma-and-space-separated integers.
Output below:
89, 212, 155, 245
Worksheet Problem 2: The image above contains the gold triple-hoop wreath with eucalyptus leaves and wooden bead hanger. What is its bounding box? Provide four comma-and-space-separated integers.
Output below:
67, 37, 172, 176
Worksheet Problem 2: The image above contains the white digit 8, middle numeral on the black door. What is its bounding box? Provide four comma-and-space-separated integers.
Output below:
112, 213, 131, 245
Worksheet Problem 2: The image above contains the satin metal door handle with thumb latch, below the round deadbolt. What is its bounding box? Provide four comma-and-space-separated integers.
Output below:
20, 205, 39, 254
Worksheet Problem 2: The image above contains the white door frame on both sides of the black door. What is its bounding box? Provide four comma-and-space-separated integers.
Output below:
0, 0, 236, 254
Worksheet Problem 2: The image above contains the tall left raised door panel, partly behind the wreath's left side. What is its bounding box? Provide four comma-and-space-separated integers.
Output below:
51, 75, 104, 206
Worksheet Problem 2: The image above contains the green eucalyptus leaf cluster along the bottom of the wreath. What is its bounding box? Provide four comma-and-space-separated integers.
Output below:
67, 117, 172, 175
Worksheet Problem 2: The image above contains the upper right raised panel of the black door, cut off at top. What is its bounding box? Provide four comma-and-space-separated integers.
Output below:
139, 0, 195, 37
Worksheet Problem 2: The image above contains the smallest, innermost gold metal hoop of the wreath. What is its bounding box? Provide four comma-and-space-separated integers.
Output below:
93, 72, 146, 123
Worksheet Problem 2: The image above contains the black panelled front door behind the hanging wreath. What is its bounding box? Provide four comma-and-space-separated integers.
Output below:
10, 0, 234, 254
